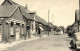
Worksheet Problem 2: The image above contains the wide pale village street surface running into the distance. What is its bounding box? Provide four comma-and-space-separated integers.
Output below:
1, 34, 75, 51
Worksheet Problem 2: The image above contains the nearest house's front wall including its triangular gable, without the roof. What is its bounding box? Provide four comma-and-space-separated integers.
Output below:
0, 8, 27, 42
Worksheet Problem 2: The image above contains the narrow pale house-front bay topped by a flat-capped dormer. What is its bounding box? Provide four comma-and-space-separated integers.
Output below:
28, 11, 37, 37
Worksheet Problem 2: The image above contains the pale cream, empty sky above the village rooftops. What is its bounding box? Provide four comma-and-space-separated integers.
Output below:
0, 0, 79, 27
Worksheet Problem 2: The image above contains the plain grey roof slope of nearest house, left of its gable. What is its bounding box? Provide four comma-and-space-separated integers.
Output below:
0, 5, 18, 17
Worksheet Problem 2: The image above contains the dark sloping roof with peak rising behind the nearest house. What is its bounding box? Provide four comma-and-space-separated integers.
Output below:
2, 0, 32, 20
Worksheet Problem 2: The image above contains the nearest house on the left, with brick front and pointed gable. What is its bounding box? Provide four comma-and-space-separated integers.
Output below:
0, 5, 26, 42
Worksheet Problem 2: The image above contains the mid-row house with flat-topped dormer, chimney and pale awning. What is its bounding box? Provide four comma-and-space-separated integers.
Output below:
25, 5, 47, 36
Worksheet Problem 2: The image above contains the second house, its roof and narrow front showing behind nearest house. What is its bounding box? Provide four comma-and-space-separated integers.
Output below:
1, 0, 33, 39
